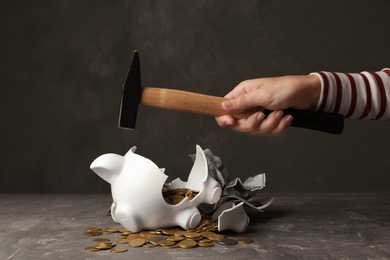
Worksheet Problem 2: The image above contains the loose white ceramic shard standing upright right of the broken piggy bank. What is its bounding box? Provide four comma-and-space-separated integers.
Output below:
213, 202, 249, 233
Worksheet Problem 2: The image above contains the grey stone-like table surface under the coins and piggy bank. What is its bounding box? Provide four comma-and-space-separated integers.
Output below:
0, 193, 390, 260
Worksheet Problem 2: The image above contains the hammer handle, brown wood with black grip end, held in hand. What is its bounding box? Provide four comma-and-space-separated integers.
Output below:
140, 87, 344, 134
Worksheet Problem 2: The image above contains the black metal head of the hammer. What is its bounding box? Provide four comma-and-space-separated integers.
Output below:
118, 51, 141, 129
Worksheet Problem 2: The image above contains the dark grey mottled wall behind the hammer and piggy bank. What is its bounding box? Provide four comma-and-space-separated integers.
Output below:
0, 0, 390, 193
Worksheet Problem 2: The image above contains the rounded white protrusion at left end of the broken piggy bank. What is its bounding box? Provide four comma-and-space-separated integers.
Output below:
90, 153, 125, 184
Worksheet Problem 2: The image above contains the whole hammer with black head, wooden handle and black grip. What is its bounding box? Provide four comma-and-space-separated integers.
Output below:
118, 51, 344, 134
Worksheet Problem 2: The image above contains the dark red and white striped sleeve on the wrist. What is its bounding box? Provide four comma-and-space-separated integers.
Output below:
311, 69, 390, 120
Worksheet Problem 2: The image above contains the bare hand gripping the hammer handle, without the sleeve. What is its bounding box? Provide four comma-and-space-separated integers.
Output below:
216, 75, 321, 134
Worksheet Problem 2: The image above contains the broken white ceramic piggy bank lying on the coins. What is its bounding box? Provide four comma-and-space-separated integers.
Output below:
91, 145, 222, 232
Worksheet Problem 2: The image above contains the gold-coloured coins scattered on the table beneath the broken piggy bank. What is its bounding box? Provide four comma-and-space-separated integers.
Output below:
84, 220, 253, 253
